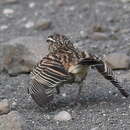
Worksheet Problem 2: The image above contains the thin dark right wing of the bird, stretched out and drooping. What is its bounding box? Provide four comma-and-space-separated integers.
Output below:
79, 55, 129, 97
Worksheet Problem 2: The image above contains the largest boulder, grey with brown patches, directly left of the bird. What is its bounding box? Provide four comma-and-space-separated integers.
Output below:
0, 37, 48, 75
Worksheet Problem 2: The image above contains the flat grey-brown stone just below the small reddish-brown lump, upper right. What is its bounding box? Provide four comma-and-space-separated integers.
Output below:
89, 32, 108, 40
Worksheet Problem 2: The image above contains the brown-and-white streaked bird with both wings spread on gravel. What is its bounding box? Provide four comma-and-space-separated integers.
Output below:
28, 34, 128, 107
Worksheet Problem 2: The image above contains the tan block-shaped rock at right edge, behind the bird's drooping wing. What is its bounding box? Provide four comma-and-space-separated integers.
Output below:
104, 53, 130, 69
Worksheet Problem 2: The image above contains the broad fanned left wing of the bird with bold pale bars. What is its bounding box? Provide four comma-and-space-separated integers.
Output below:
28, 56, 73, 106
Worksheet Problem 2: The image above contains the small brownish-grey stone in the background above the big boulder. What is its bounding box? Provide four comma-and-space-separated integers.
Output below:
34, 19, 52, 30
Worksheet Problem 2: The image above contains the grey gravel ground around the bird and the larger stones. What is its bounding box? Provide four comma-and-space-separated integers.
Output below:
0, 0, 130, 130
